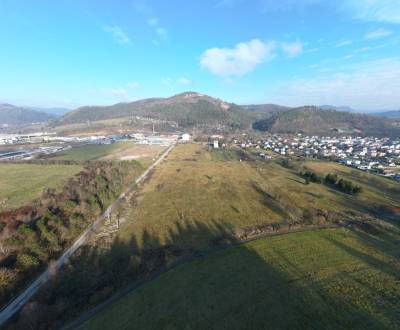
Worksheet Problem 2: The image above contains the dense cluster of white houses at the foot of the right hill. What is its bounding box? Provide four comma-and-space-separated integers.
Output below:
232, 134, 400, 181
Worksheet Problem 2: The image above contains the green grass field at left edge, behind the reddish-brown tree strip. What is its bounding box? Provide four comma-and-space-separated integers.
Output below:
0, 163, 83, 210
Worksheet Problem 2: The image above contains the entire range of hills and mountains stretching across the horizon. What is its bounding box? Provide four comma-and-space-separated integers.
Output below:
0, 92, 400, 137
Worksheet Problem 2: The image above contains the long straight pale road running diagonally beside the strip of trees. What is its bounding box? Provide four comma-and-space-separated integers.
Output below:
0, 143, 176, 326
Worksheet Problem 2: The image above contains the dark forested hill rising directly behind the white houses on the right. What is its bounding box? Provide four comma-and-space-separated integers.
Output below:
253, 106, 400, 137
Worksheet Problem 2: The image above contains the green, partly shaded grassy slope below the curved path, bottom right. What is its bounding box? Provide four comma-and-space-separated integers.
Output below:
83, 227, 400, 329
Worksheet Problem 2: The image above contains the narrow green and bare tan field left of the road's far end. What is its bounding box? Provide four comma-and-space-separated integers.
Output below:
51, 142, 165, 161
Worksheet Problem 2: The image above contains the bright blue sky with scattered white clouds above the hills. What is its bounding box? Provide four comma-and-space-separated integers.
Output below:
0, 0, 400, 111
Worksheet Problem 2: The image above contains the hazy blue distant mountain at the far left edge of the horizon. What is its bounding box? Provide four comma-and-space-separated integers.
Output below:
0, 103, 55, 125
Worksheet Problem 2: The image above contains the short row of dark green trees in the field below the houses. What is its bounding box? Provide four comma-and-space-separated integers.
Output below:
300, 171, 362, 195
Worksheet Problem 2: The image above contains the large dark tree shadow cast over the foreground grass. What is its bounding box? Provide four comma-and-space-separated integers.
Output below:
12, 221, 396, 329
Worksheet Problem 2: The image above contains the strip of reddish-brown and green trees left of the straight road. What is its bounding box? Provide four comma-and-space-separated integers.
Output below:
0, 162, 143, 305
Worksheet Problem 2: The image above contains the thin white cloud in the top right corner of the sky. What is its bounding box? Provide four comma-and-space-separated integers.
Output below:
342, 0, 400, 24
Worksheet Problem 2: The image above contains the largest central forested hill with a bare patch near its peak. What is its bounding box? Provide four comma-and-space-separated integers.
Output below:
56, 92, 260, 128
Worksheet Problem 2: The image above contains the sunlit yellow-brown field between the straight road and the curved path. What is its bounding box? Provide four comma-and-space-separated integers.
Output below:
120, 144, 400, 247
